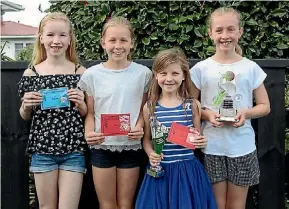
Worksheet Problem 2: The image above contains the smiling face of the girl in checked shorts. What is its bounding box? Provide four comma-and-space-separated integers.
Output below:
209, 12, 243, 53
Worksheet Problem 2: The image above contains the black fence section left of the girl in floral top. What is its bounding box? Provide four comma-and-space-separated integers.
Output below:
1, 64, 29, 209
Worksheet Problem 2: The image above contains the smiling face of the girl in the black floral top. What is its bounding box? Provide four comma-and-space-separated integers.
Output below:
40, 20, 71, 56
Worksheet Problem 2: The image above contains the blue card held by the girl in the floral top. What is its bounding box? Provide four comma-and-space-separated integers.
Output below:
40, 87, 70, 110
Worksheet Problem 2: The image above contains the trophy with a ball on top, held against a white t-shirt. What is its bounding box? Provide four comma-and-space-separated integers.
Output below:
215, 71, 238, 122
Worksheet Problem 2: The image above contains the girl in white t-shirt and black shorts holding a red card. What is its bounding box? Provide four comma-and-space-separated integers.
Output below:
79, 17, 152, 209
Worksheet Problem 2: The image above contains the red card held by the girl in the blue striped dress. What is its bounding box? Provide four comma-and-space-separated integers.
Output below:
168, 122, 199, 149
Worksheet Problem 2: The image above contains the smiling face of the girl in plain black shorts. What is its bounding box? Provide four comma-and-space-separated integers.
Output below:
101, 25, 133, 62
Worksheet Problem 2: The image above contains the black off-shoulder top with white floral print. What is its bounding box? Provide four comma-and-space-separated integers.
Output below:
18, 68, 86, 155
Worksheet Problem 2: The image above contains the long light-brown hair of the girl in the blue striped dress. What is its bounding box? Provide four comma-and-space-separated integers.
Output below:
148, 48, 197, 117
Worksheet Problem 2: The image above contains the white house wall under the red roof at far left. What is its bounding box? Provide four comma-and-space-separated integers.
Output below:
1, 38, 35, 59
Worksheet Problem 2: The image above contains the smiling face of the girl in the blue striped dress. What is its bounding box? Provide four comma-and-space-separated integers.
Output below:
155, 63, 184, 94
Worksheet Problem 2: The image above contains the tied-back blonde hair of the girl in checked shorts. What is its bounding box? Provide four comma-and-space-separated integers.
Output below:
208, 7, 243, 56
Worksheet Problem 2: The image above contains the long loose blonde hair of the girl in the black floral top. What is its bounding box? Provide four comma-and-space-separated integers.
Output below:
30, 12, 79, 66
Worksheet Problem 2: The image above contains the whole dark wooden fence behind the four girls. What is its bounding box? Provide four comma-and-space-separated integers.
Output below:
1, 60, 289, 209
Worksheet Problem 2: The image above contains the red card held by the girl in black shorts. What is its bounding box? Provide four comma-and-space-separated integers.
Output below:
101, 113, 130, 136
